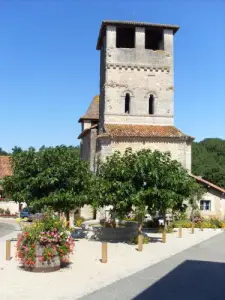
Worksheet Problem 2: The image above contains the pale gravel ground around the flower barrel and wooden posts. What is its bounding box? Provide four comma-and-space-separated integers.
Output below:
0, 229, 221, 300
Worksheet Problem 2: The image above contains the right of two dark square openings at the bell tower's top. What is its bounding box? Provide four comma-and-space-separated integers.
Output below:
145, 29, 163, 50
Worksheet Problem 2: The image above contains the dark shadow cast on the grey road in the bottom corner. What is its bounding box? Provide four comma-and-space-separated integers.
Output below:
133, 260, 225, 300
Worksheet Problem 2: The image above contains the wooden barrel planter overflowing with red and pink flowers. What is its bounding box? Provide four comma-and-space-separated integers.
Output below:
17, 212, 74, 272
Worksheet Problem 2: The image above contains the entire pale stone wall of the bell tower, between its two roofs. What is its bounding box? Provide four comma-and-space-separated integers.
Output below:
100, 26, 174, 130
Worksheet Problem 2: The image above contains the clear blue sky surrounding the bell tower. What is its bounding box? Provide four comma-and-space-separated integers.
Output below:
0, 0, 225, 151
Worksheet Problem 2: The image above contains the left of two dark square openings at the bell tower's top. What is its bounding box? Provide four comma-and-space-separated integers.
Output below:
116, 27, 135, 48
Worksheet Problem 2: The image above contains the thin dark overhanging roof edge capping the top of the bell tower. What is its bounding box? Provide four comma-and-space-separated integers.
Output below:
96, 20, 180, 50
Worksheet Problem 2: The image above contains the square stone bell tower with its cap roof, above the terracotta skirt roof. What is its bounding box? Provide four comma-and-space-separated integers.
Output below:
97, 21, 179, 126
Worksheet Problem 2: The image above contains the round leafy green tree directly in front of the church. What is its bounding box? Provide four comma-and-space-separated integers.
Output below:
92, 149, 200, 231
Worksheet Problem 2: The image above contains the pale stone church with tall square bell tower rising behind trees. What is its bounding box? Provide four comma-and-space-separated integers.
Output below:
78, 21, 225, 219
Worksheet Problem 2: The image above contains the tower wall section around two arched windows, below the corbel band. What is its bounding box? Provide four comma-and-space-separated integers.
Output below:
105, 67, 174, 125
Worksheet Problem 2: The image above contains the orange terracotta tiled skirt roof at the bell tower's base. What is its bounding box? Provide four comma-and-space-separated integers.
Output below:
105, 124, 193, 139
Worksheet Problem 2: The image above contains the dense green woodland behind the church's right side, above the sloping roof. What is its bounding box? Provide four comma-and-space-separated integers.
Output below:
192, 138, 225, 188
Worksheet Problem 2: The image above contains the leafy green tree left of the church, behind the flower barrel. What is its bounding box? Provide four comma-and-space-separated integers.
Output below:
3, 146, 92, 215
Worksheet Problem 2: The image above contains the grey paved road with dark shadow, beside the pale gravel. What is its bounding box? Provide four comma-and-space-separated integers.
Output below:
81, 233, 225, 300
